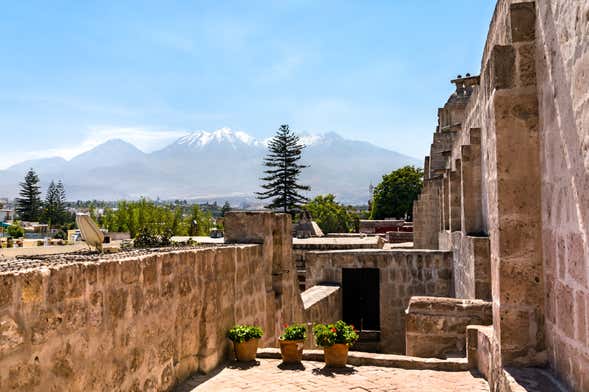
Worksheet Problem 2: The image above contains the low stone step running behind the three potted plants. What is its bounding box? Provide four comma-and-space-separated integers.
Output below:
256, 348, 469, 372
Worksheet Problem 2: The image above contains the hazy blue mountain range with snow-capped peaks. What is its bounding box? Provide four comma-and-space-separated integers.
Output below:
0, 128, 421, 203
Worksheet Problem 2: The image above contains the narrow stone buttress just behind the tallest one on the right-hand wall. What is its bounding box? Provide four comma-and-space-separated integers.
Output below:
461, 128, 483, 235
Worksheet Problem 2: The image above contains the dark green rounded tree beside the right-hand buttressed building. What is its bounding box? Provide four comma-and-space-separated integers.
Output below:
370, 166, 423, 220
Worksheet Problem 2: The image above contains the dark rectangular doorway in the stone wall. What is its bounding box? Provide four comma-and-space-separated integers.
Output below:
342, 268, 380, 331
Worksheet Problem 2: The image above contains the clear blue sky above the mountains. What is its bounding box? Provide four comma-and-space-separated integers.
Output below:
0, 0, 495, 168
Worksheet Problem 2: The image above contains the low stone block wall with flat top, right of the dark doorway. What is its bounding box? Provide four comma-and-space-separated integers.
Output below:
405, 297, 493, 358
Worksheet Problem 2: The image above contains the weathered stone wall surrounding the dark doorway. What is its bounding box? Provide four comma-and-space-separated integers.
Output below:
306, 250, 453, 353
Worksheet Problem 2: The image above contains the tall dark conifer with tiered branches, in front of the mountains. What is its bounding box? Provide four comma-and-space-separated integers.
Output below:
256, 125, 311, 215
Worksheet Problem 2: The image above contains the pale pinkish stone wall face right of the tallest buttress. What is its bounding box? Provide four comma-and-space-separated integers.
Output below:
536, 0, 589, 391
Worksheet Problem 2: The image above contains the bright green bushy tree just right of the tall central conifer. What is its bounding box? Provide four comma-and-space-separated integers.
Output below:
304, 193, 357, 234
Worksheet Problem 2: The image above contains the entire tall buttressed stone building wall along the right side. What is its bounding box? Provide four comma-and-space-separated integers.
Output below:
414, 0, 589, 391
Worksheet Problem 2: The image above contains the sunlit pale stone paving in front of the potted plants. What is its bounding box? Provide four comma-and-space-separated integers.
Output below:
175, 359, 489, 392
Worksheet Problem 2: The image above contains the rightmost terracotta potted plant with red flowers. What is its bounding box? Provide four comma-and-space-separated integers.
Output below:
313, 320, 358, 367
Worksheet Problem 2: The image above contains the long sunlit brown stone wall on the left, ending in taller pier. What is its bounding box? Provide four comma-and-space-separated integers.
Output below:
0, 214, 302, 391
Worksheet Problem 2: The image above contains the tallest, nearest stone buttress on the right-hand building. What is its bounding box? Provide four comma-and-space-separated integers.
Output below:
485, 3, 546, 366
